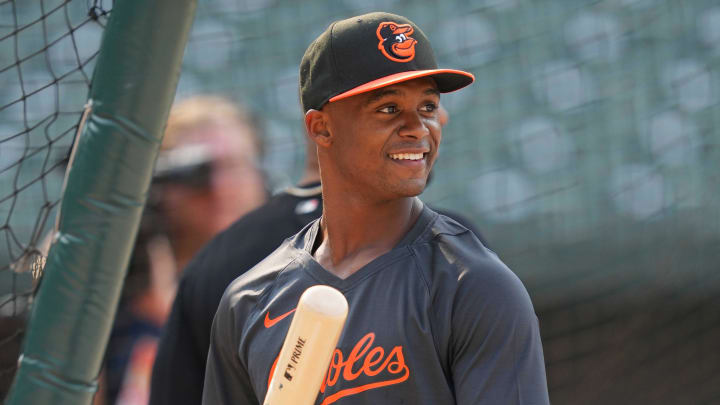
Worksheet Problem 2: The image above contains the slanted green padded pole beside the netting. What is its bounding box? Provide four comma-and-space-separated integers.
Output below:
6, 0, 196, 405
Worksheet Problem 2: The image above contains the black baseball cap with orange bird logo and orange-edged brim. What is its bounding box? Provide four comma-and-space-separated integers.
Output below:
300, 12, 475, 112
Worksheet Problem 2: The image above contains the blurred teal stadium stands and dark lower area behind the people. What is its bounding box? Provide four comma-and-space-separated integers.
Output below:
0, 0, 720, 404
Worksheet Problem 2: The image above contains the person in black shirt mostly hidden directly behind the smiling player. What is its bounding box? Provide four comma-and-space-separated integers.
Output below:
150, 98, 487, 405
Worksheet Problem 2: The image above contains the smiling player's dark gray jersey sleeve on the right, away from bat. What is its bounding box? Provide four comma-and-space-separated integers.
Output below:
451, 252, 550, 405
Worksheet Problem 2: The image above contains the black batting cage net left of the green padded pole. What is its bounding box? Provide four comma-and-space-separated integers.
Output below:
0, 0, 111, 403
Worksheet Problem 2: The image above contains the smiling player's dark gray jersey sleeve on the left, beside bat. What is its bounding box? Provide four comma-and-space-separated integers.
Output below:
202, 290, 258, 405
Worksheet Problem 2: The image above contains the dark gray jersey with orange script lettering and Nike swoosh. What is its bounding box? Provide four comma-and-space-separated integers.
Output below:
203, 207, 549, 405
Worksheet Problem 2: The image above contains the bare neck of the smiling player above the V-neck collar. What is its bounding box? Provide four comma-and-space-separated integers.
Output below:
313, 194, 422, 278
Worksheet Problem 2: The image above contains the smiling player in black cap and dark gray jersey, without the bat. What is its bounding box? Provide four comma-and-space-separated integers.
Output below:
203, 13, 549, 405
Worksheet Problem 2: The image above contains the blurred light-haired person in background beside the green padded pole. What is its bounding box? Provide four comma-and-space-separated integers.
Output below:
96, 96, 267, 405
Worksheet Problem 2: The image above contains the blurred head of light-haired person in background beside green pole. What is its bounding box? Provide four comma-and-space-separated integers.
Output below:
151, 96, 268, 269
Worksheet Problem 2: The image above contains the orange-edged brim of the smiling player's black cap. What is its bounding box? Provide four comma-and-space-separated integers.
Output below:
328, 69, 475, 102
